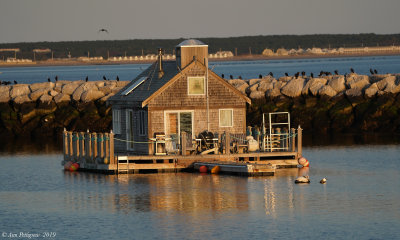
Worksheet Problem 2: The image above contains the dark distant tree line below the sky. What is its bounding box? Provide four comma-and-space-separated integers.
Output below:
0, 33, 400, 60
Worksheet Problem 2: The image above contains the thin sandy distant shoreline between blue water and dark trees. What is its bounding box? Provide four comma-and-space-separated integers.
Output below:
0, 52, 400, 68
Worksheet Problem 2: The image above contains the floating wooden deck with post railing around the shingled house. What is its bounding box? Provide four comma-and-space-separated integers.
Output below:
62, 127, 302, 176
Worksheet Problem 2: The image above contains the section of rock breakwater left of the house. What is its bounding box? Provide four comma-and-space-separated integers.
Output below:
0, 81, 128, 138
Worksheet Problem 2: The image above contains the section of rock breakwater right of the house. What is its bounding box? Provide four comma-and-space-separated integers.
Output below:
229, 73, 400, 133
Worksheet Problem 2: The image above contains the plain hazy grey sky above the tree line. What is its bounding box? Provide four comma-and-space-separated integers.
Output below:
0, 0, 400, 43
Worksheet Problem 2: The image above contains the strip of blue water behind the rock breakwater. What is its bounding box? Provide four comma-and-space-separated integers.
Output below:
0, 56, 400, 83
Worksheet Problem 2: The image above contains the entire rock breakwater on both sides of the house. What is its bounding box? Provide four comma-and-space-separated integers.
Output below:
0, 73, 400, 140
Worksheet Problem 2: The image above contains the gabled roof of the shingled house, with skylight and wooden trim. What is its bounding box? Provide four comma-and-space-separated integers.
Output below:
108, 57, 251, 107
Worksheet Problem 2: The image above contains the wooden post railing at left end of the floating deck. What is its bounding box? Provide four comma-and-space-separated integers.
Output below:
63, 129, 116, 164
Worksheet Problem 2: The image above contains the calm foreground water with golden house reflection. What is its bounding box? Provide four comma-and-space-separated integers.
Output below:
0, 141, 400, 239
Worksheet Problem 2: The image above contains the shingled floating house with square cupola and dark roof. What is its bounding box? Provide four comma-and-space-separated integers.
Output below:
108, 39, 251, 155
